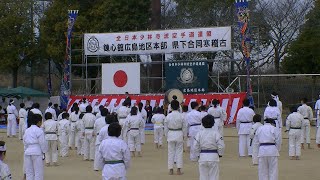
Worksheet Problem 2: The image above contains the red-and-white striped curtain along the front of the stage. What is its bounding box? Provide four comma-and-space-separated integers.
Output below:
69, 93, 246, 124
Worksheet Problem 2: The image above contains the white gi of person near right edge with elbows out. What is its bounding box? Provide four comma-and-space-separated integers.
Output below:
298, 104, 313, 144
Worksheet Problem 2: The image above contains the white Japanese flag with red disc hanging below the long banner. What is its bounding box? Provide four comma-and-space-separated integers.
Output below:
102, 63, 140, 94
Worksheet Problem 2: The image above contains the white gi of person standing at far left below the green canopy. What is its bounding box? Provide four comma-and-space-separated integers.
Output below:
7, 104, 19, 137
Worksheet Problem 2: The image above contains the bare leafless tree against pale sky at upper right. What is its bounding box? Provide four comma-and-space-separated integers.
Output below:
256, 0, 314, 73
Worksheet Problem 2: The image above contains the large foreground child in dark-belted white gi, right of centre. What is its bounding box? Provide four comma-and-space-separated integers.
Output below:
194, 115, 225, 180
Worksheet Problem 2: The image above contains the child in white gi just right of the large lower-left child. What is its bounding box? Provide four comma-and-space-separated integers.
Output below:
43, 112, 58, 166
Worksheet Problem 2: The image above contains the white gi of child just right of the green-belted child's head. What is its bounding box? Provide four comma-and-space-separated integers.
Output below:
125, 115, 144, 152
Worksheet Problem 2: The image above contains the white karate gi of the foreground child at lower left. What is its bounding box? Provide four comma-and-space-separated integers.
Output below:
23, 125, 48, 180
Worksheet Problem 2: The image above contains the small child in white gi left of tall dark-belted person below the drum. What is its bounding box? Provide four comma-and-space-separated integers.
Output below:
151, 107, 166, 149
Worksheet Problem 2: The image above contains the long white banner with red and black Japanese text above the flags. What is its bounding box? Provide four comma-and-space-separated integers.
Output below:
84, 27, 231, 56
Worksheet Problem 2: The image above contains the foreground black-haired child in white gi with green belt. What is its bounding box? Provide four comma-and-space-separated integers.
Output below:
97, 123, 130, 180
